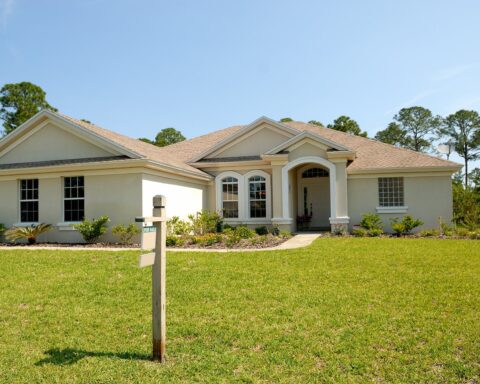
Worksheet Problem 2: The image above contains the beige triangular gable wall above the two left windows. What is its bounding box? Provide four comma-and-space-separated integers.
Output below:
0, 123, 112, 164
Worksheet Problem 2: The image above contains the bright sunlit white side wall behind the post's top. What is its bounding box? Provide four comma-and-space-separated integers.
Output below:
141, 174, 204, 219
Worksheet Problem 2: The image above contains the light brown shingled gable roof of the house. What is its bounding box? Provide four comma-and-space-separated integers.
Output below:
0, 111, 461, 179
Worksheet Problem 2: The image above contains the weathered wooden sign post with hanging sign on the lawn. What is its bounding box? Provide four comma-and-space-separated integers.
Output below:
135, 195, 167, 363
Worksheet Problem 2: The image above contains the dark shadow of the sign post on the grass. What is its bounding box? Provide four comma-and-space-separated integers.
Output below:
35, 348, 151, 366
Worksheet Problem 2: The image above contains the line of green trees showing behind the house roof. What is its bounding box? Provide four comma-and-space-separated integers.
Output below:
0, 82, 480, 186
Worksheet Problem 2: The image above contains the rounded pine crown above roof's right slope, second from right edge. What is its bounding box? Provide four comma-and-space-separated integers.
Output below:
379, 107, 443, 152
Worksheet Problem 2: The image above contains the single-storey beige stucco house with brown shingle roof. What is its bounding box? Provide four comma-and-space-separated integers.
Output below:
0, 111, 461, 242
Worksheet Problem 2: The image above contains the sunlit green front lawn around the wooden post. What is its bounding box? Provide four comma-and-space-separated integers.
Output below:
0, 238, 480, 383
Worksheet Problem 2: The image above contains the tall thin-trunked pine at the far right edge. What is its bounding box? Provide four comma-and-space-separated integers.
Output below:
439, 109, 480, 187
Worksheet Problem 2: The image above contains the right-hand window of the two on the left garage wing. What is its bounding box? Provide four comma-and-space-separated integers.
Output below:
63, 176, 85, 222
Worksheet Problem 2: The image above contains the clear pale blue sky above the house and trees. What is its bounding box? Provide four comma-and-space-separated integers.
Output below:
0, 0, 480, 164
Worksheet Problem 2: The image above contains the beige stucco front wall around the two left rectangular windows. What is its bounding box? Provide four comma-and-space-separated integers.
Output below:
0, 173, 142, 243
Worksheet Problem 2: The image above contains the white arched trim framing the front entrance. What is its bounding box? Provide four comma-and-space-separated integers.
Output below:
282, 156, 337, 220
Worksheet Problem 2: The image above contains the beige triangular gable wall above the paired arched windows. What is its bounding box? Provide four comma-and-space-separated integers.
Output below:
208, 124, 290, 157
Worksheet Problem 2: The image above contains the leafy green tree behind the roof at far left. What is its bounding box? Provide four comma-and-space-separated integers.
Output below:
0, 82, 57, 134
